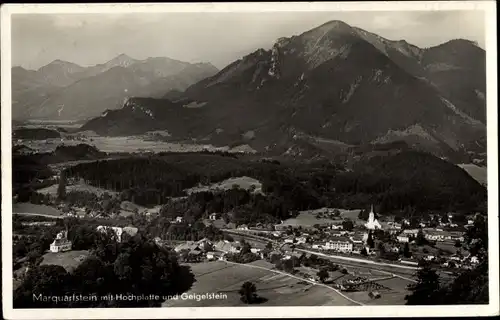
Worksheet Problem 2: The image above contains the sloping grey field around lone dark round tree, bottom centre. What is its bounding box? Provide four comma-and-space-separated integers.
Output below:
163, 260, 362, 307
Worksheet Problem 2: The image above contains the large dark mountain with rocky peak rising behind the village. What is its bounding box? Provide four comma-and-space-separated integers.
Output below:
82, 21, 486, 157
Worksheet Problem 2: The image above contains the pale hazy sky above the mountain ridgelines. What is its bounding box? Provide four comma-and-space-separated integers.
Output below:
12, 11, 485, 69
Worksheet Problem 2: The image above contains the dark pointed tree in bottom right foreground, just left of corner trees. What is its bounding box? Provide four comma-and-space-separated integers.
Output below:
405, 263, 440, 305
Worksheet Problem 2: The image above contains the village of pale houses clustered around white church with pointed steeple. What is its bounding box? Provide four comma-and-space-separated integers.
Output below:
166, 207, 478, 269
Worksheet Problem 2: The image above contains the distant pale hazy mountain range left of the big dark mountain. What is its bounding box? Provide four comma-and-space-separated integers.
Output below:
12, 54, 218, 120
